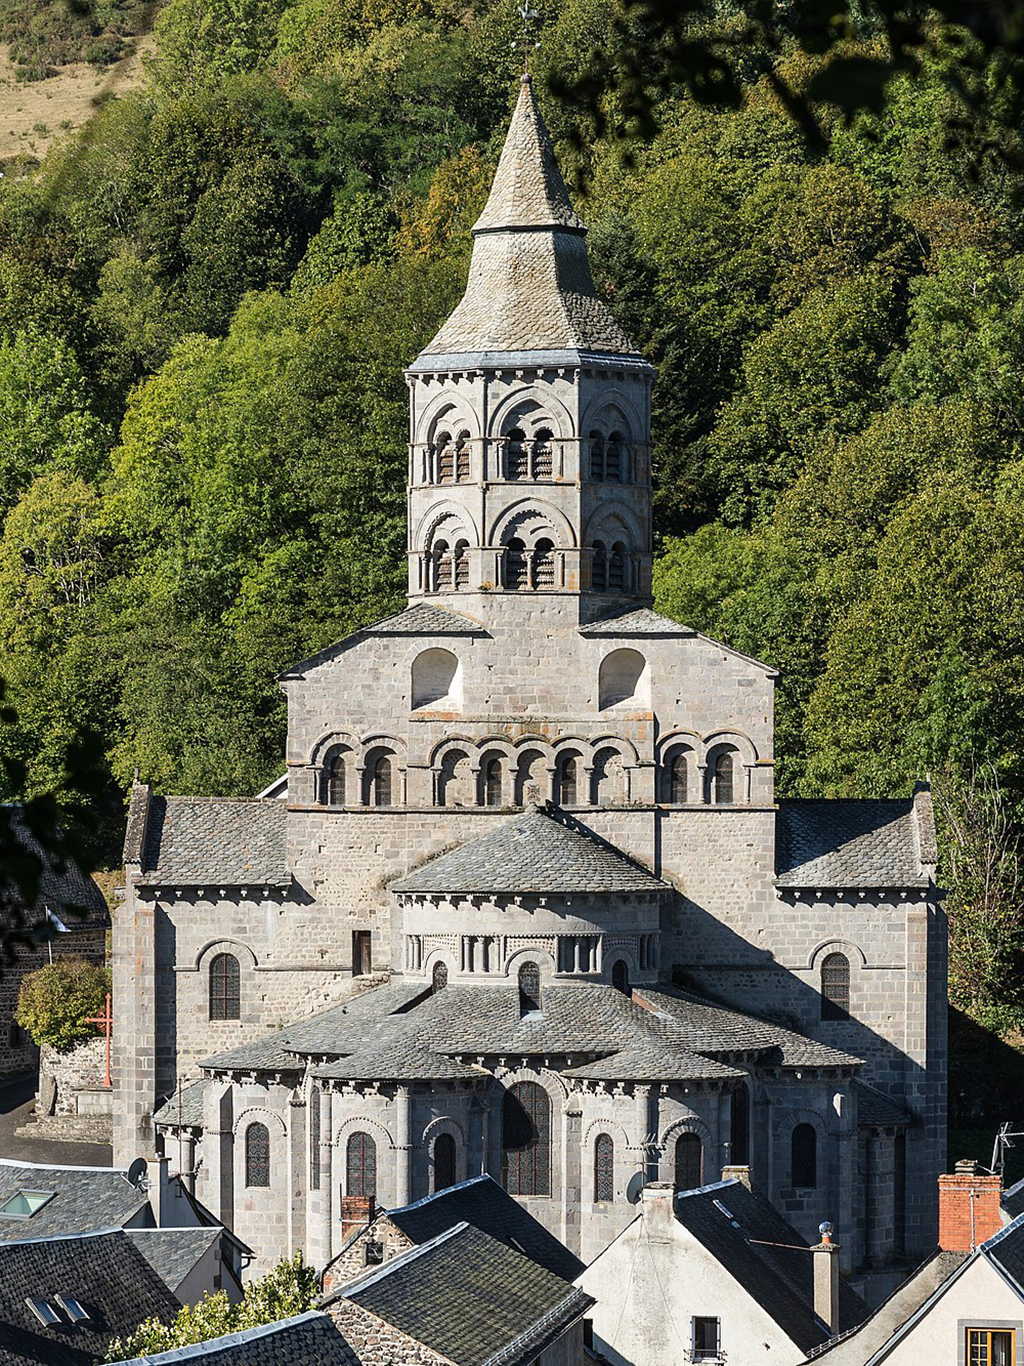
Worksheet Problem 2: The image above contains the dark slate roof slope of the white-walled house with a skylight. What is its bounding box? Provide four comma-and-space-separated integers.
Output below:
676, 1180, 867, 1351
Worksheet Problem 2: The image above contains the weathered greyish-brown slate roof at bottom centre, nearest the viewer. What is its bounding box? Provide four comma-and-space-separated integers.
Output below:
334, 1223, 594, 1366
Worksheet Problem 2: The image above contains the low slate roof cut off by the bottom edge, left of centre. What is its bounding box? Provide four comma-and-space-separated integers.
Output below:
117, 1310, 359, 1366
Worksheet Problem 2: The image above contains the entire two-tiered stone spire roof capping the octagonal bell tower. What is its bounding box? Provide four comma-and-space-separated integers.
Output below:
411, 76, 644, 372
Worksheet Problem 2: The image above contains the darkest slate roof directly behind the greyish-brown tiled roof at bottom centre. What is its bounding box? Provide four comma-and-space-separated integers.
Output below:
388, 1175, 586, 1281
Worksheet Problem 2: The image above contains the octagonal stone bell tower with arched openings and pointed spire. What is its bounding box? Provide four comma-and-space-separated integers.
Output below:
406, 75, 654, 622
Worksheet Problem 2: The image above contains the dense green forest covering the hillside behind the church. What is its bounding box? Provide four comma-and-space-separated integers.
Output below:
0, 0, 1024, 1027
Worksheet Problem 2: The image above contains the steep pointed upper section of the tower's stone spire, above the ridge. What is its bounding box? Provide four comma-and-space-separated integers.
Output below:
472, 75, 586, 232
